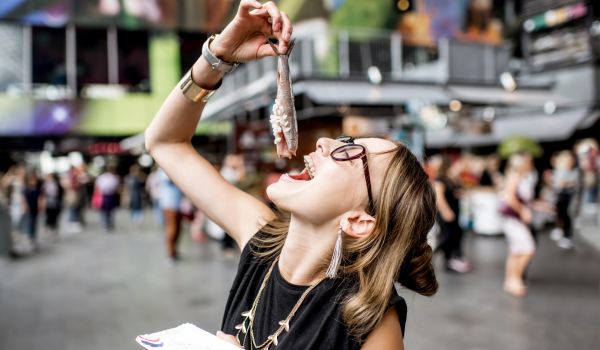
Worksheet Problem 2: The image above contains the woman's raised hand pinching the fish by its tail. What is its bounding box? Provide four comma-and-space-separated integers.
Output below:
210, 0, 292, 62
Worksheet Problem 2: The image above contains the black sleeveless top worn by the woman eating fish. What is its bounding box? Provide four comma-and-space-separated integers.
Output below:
221, 233, 407, 350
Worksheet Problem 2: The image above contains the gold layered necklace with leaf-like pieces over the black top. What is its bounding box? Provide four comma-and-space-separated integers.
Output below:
235, 257, 325, 350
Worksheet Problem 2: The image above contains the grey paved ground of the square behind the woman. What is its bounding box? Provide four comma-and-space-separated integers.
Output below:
0, 213, 600, 350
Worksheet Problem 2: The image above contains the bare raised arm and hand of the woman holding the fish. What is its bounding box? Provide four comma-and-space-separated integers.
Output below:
145, 0, 292, 248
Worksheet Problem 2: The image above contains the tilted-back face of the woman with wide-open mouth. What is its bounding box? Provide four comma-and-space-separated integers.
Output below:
267, 138, 396, 223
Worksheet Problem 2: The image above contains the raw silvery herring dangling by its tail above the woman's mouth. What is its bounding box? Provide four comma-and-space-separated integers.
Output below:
269, 40, 298, 158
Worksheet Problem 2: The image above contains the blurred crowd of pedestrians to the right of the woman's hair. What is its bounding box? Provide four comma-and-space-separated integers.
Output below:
426, 139, 600, 297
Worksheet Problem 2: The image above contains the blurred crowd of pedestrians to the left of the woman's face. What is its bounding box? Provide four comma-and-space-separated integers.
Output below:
0, 154, 285, 264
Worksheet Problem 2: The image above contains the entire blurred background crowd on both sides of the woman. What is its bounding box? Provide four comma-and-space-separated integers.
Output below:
0, 139, 600, 288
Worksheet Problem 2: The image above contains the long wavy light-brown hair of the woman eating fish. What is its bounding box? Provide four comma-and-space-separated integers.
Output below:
251, 144, 438, 339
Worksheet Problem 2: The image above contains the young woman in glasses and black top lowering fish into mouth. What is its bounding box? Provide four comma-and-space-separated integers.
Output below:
146, 0, 437, 350
